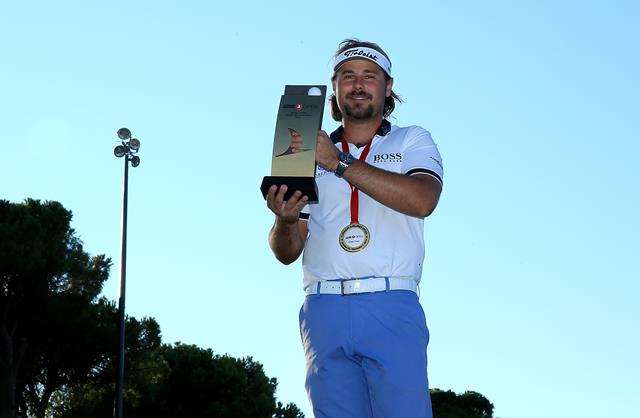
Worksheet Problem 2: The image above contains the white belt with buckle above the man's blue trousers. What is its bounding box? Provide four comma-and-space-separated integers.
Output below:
305, 277, 418, 295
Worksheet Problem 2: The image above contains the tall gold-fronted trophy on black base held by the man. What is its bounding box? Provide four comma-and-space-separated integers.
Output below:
260, 86, 327, 203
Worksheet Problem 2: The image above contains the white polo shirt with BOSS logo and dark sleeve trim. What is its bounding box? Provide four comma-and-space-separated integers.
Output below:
300, 120, 443, 288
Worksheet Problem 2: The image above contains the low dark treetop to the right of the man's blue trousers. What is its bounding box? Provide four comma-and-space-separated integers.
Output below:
431, 389, 493, 418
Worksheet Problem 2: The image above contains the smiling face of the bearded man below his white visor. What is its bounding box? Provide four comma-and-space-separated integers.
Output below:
333, 59, 393, 120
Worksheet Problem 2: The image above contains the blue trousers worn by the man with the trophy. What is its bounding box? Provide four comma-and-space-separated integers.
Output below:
300, 290, 432, 418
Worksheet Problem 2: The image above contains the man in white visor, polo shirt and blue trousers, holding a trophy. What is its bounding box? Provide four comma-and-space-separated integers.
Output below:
267, 39, 443, 418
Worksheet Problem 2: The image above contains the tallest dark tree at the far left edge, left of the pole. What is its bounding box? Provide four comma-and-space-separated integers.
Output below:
0, 199, 111, 418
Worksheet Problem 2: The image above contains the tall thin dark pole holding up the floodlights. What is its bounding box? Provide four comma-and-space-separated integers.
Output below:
114, 155, 129, 418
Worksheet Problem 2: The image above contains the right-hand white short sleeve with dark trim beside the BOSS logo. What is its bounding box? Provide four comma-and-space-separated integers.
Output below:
401, 126, 444, 184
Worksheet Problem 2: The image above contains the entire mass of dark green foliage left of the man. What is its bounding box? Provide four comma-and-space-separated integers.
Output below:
0, 200, 303, 418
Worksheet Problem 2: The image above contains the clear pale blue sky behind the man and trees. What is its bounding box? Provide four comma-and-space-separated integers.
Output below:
0, 0, 640, 418
